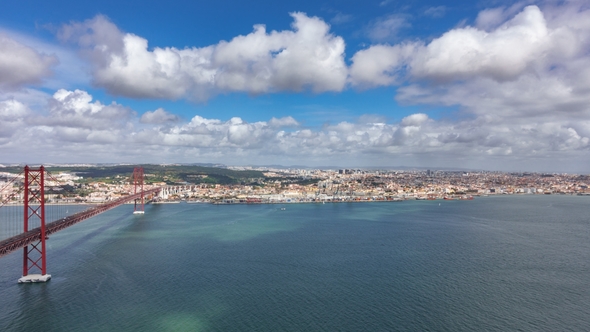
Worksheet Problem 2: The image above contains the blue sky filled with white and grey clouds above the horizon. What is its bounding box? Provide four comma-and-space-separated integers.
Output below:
0, 0, 590, 174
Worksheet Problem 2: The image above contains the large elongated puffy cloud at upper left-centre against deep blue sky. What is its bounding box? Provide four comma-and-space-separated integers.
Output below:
59, 13, 347, 100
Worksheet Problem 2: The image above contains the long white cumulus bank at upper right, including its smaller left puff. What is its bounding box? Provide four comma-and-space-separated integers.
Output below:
351, 6, 564, 85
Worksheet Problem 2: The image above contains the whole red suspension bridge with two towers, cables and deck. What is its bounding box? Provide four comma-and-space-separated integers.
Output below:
0, 166, 162, 283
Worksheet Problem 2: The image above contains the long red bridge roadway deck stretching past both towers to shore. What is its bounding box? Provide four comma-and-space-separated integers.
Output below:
0, 188, 161, 257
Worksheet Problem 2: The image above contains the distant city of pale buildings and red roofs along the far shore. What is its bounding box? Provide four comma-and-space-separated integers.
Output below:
0, 166, 590, 204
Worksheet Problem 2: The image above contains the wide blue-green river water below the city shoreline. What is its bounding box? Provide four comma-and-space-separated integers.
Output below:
0, 196, 590, 331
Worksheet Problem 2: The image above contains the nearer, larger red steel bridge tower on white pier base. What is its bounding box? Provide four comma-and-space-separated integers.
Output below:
18, 166, 51, 283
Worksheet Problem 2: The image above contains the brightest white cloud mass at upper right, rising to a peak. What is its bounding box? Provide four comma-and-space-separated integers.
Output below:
410, 6, 552, 81
